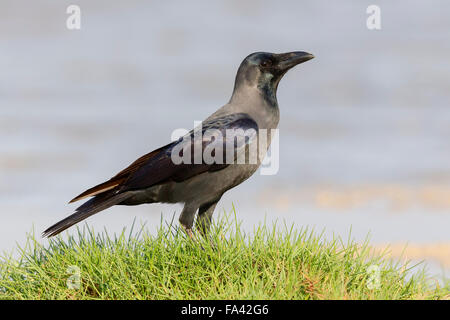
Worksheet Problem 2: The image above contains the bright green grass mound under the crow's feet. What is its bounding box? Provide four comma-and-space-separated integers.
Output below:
0, 212, 449, 299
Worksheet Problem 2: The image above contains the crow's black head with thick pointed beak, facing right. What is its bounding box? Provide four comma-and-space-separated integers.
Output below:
233, 51, 314, 102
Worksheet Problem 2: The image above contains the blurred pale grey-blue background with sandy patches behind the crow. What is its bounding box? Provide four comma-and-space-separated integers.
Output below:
0, 0, 450, 276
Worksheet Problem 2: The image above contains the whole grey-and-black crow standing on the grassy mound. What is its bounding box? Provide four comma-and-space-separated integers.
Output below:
42, 51, 314, 238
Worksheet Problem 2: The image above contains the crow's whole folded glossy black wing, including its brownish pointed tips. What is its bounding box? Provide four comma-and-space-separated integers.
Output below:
71, 113, 258, 202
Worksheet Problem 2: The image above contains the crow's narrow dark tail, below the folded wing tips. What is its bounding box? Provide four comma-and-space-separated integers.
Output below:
42, 192, 131, 238
